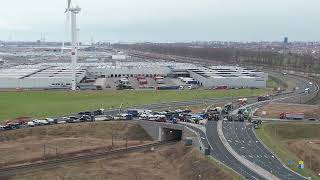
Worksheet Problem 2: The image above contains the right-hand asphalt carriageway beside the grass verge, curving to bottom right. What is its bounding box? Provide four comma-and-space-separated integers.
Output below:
222, 121, 304, 180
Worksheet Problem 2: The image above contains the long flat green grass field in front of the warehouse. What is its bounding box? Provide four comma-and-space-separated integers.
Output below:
0, 89, 269, 120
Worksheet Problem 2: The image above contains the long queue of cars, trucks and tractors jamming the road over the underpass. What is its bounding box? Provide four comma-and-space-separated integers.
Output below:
0, 91, 314, 134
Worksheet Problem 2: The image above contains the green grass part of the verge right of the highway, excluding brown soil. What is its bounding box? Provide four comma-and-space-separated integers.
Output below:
256, 123, 320, 180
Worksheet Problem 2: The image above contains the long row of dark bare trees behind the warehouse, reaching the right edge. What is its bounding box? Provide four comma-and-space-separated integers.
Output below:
114, 44, 320, 72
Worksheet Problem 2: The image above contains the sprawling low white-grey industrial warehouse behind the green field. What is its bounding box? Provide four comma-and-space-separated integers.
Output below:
0, 60, 268, 89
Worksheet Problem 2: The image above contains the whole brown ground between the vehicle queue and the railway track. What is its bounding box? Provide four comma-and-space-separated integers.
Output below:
0, 122, 152, 167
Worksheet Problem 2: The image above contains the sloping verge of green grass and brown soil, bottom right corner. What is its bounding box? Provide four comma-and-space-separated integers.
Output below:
256, 123, 320, 179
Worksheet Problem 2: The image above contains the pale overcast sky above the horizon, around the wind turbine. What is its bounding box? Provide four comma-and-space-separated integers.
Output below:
0, 0, 320, 42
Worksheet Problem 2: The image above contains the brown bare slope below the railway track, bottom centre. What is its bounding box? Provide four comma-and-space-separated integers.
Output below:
13, 144, 233, 180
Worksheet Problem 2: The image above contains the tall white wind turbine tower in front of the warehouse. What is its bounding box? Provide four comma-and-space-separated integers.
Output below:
65, 0, 81, 91
